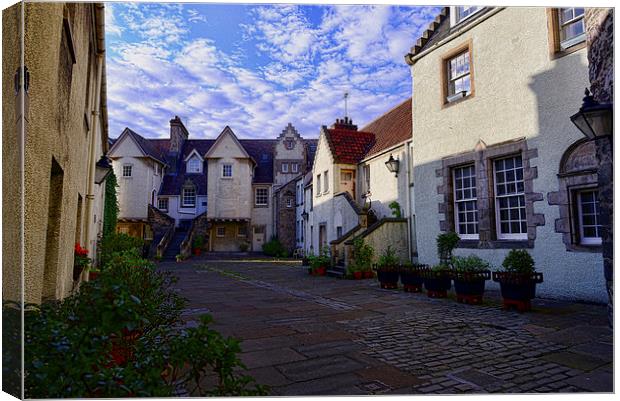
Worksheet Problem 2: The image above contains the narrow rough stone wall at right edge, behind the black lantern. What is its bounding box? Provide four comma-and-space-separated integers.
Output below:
584, 8, 614, 325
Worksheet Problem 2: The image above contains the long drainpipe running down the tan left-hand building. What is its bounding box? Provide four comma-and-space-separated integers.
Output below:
84, 3, 105, 266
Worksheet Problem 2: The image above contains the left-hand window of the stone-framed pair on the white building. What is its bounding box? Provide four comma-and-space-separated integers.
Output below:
453, 165, 478, 239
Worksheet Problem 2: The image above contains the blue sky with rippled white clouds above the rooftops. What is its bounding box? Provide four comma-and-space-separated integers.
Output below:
105, 3, 440, 139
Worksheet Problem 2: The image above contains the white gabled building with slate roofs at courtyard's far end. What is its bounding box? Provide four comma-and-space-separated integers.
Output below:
109, 117, 315, 252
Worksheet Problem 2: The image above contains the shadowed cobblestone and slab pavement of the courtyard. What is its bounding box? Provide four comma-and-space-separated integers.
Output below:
160, 258, 613, 395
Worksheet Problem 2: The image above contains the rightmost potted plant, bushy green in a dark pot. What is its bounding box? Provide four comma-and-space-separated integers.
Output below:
493, 249, 543, 312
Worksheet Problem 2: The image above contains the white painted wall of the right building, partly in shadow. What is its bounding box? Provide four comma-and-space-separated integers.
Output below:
412, 7, 607, 302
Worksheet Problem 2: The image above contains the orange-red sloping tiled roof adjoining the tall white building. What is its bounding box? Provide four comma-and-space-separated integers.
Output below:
362, 98, 413, 157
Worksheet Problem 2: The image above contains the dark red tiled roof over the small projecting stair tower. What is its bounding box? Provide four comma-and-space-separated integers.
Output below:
325, 128, 375, 164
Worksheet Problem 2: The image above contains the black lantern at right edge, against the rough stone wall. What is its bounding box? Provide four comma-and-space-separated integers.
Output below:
570, 88, 613, 139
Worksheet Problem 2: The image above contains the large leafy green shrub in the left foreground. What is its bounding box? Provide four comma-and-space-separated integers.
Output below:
25, 250, 266, 398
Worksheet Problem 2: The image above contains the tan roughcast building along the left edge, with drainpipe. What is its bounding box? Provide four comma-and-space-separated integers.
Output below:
2, 2, 108, 302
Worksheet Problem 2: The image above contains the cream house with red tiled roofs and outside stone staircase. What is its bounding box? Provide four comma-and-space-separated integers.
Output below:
304, 99, 415, 273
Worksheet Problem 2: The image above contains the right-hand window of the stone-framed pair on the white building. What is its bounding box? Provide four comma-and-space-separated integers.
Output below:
494, 155, 527, 240
